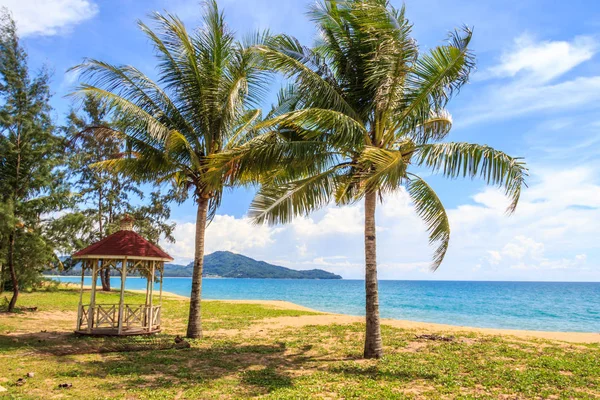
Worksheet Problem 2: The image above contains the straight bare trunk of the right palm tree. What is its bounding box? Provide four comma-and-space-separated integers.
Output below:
364, 192, 383, 358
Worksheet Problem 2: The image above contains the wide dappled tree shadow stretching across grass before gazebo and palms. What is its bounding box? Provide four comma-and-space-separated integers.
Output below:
0, 332, 437, 397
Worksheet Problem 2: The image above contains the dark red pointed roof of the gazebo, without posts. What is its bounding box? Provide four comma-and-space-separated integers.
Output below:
73, 230, 173, 261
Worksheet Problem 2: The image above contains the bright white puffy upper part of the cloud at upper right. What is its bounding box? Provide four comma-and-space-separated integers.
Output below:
488, 34, 598, 83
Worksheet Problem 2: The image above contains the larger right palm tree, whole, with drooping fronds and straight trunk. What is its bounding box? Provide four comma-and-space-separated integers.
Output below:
217, 0, 527, 358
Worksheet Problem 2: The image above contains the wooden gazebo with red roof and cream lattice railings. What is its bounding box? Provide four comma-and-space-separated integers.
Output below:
73, 216, 173, 336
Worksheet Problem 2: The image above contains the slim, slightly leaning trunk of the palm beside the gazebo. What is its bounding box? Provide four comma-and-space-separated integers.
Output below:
186, 196, 208, 339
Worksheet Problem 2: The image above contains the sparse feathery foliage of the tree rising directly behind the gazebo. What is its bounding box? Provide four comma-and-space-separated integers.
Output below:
61, 95, 174, 254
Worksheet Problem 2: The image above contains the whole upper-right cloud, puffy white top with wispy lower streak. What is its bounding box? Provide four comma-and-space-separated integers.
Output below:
456, 35, 600, 126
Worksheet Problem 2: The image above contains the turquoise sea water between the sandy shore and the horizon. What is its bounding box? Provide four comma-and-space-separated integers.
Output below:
52, 277, 600, 332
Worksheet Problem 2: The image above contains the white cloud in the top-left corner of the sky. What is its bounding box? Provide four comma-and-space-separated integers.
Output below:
0, 0, 98, 37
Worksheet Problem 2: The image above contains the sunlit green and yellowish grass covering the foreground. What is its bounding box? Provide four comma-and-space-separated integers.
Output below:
0, 290, 600, 399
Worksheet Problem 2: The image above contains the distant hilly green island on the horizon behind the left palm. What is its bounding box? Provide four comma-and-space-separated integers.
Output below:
46, 251, 342, 279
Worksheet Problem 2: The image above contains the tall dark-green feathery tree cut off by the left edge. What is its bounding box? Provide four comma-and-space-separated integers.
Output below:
0, 11, 69, 309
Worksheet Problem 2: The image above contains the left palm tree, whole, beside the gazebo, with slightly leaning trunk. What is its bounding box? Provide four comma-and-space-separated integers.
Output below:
75, 1, 266, 338
